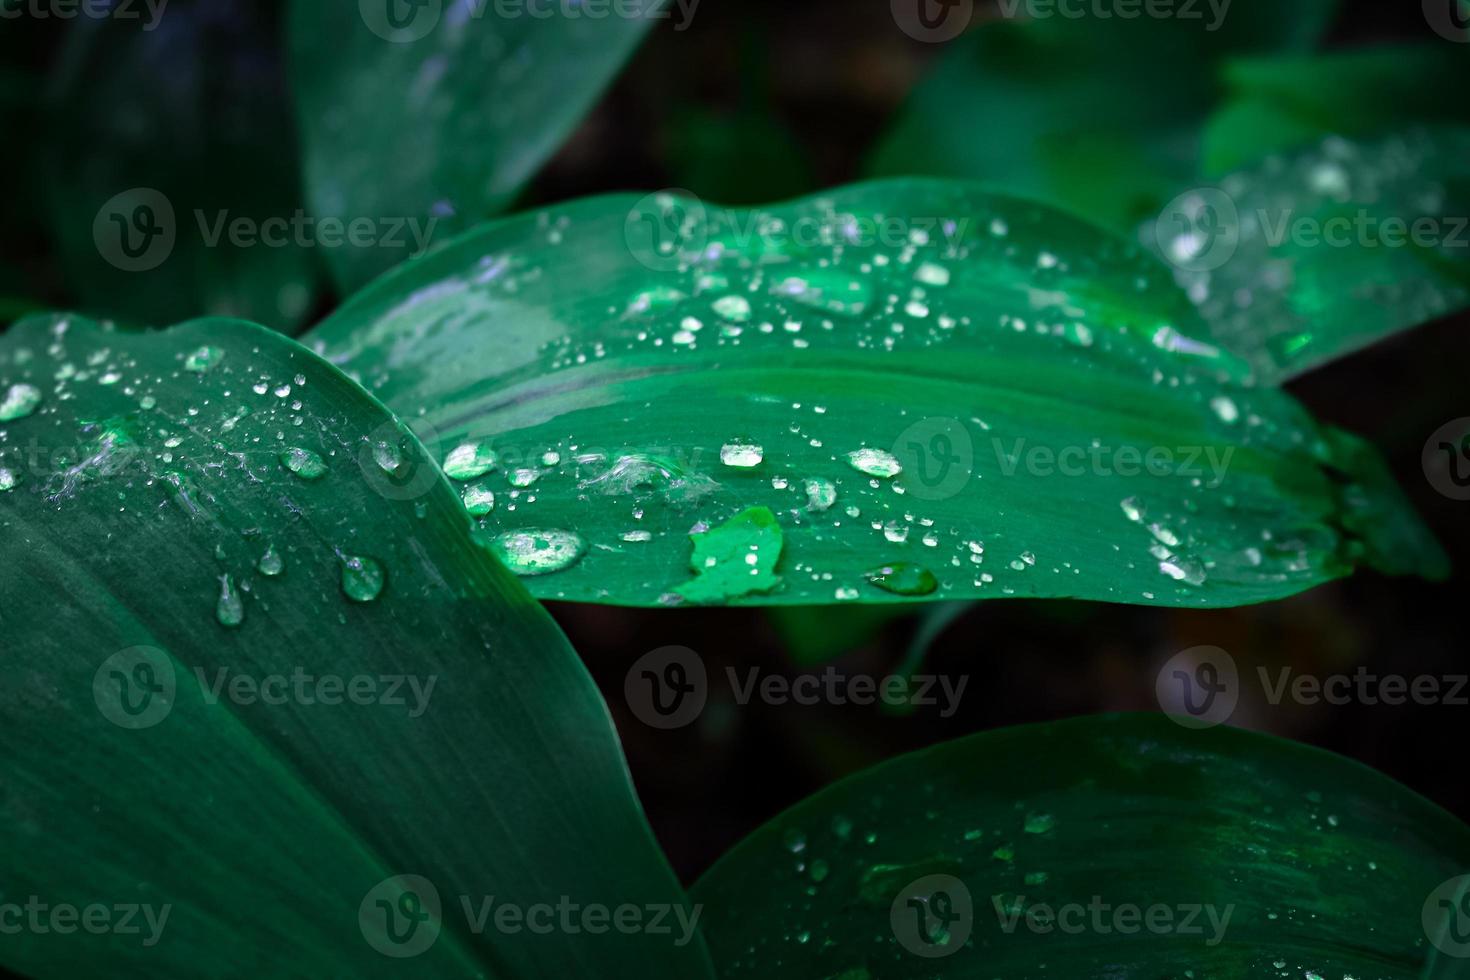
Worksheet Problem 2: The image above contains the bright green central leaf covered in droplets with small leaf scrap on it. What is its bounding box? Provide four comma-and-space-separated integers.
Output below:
309, 181, 1441, 605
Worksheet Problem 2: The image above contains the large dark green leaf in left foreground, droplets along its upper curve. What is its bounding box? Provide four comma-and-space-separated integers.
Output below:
0, 317, 709, 979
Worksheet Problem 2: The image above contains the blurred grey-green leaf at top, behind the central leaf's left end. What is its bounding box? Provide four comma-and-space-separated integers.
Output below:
288, 0, 672, 289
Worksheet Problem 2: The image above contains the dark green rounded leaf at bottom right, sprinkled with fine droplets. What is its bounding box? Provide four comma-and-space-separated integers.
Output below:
692, 716, 1470, 980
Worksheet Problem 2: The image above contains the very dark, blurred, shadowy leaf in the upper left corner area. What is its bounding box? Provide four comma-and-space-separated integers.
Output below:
44, 0, 316, 331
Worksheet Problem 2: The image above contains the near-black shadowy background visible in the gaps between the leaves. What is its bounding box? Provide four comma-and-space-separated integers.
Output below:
0, 0, 1470, 880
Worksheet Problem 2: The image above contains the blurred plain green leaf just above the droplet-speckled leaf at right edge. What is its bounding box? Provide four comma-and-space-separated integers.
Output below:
1204, 41, 1470, 178
